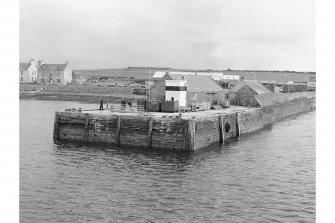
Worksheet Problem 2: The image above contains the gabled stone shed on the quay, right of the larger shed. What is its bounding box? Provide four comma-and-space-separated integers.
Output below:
229, 80, 272, 107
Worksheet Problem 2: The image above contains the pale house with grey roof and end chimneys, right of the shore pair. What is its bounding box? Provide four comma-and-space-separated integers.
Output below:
37, 61, 72, 85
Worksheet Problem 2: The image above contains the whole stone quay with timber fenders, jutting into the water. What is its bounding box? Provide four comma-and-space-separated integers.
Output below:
53, 92, 316, 151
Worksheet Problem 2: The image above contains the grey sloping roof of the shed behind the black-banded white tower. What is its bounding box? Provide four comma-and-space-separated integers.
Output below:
167, 74, 225, 92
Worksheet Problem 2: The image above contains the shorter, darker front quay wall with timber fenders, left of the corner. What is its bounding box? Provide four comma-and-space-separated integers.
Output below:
54, 112, 189, 150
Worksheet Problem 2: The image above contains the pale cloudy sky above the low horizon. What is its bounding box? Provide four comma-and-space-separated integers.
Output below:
20, 0, 315, 71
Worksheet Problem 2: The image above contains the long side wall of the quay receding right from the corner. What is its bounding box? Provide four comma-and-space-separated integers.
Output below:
194, 93, 315, 150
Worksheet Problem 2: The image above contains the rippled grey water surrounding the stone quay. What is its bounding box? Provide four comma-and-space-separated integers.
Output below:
20, 100, 315, 222
